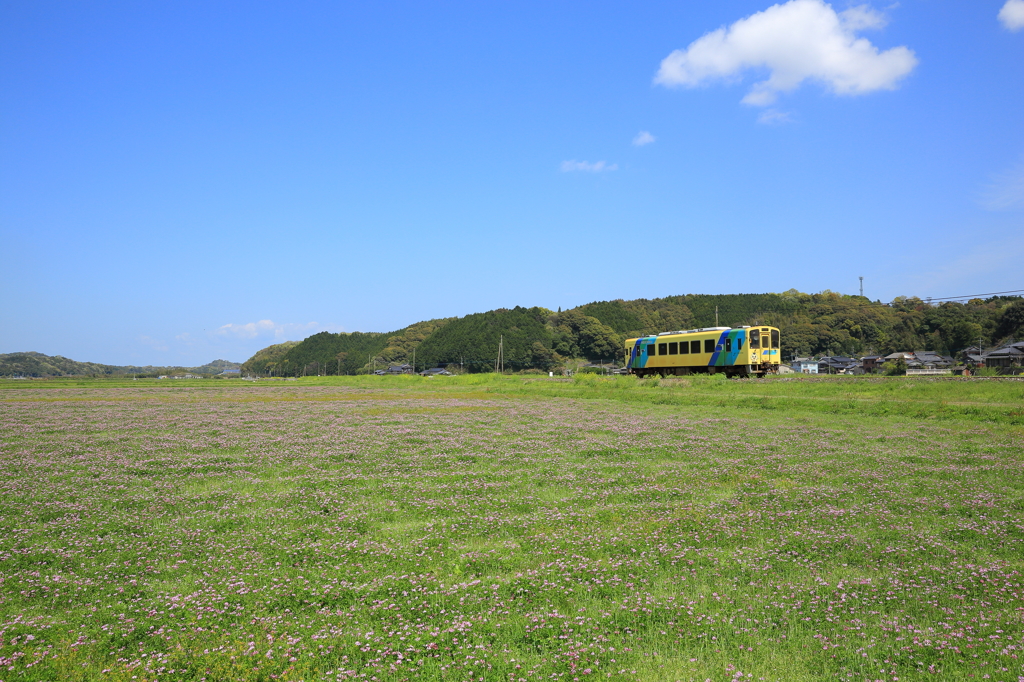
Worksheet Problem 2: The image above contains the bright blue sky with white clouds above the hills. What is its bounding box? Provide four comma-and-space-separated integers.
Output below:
0, 0, 1024, 366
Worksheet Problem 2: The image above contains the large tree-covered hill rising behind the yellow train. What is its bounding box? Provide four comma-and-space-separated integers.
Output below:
243, 290, 1024, 375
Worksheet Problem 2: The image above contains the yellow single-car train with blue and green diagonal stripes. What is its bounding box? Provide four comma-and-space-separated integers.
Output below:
626, 326, 780, 377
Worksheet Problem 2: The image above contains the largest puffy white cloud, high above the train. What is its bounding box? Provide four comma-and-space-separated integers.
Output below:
654, 0, 921, 106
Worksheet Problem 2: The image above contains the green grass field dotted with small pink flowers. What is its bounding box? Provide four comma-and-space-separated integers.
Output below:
0, 375, 1024, 682
